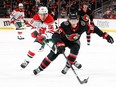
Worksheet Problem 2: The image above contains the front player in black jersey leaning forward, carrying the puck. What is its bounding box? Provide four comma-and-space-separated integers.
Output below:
33, 13, 114, 75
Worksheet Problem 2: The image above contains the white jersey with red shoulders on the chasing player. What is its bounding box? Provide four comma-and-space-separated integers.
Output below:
30, 14, 55, 38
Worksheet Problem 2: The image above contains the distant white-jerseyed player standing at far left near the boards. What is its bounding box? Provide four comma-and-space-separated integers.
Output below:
10, 3, 25, 40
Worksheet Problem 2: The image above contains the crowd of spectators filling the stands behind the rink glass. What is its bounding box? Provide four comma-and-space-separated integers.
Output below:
3, 0, 116, 19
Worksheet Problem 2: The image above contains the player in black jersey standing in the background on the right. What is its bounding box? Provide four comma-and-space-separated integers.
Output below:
78, 2, 94, 45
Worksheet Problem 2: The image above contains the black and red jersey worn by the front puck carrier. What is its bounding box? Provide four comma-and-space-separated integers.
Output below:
52, 21, 104, 44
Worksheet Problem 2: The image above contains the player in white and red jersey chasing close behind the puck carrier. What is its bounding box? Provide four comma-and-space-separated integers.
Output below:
21, 6, 55, 68
